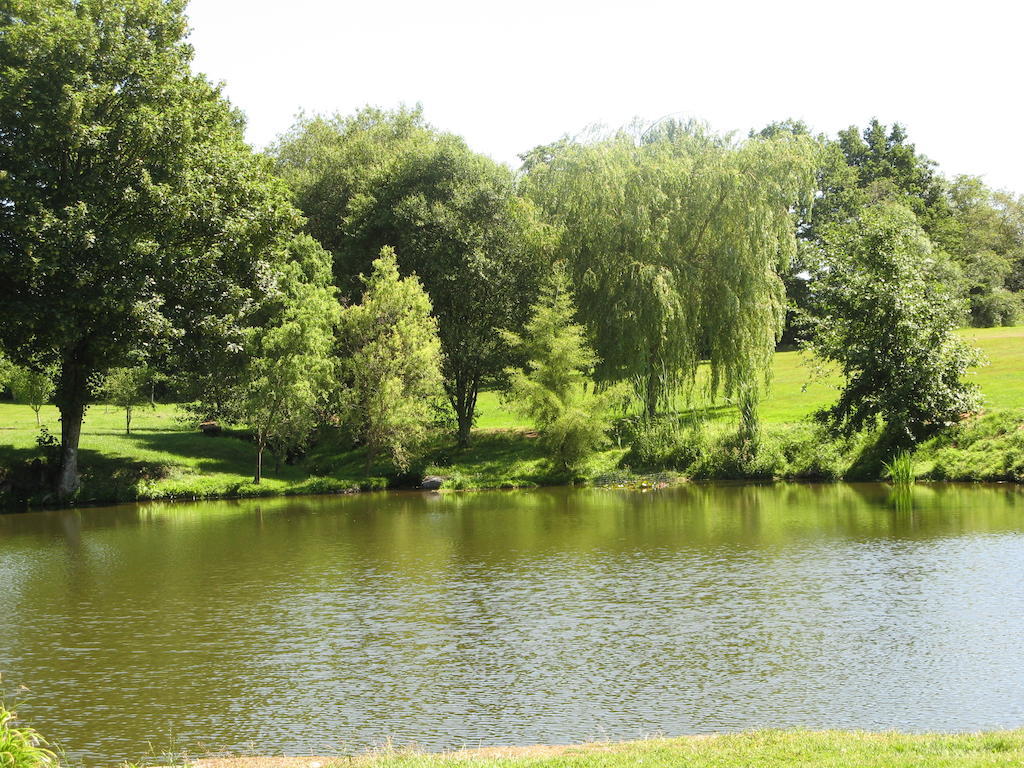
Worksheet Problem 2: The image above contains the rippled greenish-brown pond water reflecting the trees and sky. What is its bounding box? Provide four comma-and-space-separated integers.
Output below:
0, 485, 1024, 765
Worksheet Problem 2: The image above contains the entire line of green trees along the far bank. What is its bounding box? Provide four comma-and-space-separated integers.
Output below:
0, 0, 1024, 497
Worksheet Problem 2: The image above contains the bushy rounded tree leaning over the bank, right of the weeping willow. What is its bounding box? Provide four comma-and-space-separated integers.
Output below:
809, 203, 978, 447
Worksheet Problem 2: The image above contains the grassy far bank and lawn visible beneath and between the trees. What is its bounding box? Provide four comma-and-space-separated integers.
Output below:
0, 327, 1024, 503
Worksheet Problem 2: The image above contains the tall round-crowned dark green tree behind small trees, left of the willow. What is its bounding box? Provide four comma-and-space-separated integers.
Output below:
273, 109, 549, 444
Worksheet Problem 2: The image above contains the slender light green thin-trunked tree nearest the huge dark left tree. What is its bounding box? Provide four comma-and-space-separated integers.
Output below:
225, 236, 340, 484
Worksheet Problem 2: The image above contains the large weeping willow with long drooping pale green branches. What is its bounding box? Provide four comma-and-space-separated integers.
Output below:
523, 122, 816, 434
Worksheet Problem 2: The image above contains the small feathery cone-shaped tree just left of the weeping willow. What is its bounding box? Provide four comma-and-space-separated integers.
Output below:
506, 264, 626, 472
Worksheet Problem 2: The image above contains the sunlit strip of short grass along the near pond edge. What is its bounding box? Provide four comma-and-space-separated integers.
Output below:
176, 730, 1024, 768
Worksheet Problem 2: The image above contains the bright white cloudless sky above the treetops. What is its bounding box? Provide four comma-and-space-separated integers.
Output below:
188, 0, 1024, 193
